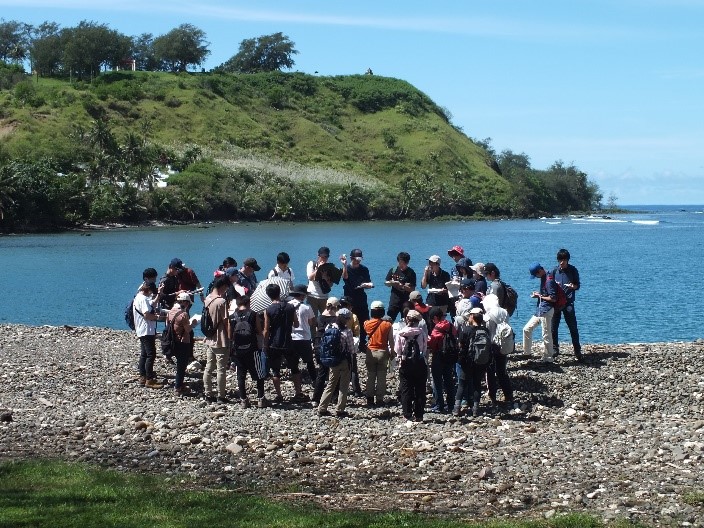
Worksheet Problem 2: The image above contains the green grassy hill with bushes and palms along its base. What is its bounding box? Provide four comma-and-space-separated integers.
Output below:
0, 67, 590, 230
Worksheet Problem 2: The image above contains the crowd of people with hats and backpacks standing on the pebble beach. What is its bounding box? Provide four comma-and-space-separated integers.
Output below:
133, 245, 582, 421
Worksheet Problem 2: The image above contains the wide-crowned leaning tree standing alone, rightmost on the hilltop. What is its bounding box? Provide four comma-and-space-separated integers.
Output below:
216, 32, 298, 73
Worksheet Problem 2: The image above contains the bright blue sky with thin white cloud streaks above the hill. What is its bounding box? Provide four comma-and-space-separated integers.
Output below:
0, 0, 704, 205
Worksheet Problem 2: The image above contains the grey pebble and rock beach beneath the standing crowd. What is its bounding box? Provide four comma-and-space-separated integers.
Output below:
0, 325, 704, 526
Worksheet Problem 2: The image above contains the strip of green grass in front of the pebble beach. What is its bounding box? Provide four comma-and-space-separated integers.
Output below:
0, 461, 620, 528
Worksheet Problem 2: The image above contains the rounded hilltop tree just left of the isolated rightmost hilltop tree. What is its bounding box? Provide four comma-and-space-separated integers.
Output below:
153, 24, 210, 72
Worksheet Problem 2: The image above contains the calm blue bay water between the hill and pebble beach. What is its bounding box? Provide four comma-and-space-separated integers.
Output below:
0, 206, 704, 343
